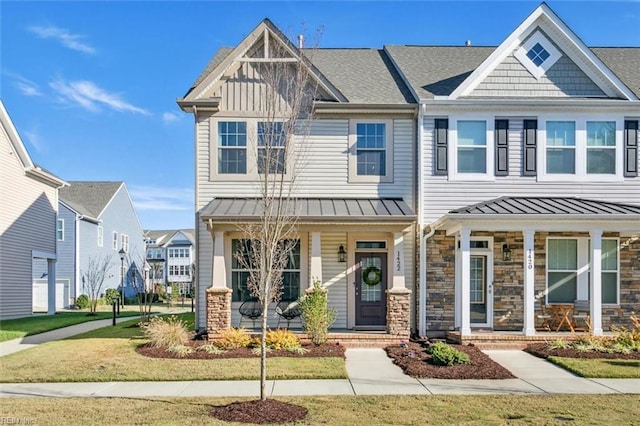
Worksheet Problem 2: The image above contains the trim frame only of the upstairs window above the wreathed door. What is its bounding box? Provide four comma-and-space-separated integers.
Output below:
349, 118, 394, 183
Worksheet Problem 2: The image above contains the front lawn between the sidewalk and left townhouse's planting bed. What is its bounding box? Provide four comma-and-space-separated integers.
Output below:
0, 314, 347, 383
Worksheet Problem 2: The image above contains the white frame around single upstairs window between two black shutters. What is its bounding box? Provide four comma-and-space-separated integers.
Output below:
447, 114, 496, 182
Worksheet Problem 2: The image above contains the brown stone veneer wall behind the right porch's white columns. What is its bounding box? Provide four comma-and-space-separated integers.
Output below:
427, 231, 640, 336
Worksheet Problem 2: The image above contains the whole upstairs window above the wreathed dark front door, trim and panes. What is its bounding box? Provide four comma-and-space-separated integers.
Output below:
349, 119, 393, 183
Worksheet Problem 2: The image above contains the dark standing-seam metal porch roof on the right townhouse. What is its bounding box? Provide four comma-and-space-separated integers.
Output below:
433, 197, 640, 233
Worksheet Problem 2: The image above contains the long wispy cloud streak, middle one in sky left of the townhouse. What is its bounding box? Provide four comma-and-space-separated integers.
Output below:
49, 78, 150, 115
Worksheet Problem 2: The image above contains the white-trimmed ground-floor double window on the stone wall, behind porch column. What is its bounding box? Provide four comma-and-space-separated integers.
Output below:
547, 237, 620, 305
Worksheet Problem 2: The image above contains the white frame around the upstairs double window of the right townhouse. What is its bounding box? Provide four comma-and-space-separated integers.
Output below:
537, 115, 624, 182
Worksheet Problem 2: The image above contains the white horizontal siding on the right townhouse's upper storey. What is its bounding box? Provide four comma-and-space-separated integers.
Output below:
422, 117, 640, 224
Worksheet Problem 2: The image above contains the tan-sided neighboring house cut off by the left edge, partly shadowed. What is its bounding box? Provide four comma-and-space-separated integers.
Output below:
0, 100, 66, 319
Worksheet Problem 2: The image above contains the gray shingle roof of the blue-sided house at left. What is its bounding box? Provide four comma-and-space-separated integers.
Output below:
59, 181, 124, 219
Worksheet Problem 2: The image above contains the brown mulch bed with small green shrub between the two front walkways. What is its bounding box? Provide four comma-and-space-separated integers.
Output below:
385, 342, 515, 379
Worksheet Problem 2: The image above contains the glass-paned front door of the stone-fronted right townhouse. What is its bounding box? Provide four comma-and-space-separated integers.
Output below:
469, 254, 493, 327
